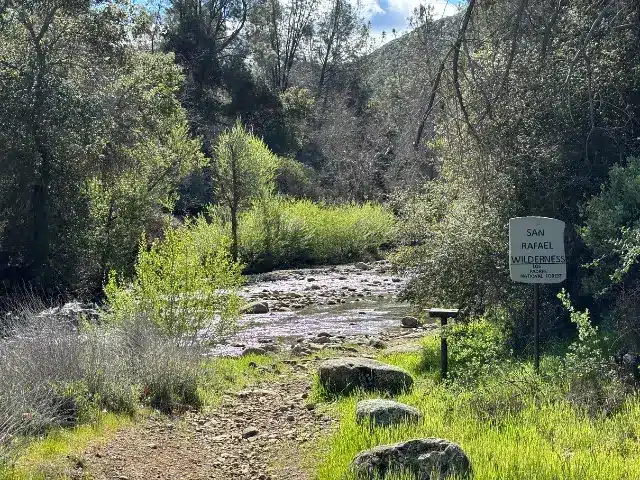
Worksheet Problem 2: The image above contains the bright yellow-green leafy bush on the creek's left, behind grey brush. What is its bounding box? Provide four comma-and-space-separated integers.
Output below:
105, 218, 242, 339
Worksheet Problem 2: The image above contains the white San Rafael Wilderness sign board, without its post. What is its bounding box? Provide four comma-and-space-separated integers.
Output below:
509, 217, 567, 283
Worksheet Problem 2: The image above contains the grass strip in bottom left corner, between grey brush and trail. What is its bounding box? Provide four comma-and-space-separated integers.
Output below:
0, 413, 133, 480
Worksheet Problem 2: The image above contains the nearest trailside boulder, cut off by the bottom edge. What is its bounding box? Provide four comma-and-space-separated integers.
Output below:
351, 438, 471, 480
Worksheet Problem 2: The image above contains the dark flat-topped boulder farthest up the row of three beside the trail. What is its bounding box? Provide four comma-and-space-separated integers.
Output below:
318, 357, 413, 395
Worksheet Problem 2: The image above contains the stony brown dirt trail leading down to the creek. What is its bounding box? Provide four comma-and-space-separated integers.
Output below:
78, 360, 332, 480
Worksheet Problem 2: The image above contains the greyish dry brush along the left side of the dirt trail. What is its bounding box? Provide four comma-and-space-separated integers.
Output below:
0, 308, 202, 460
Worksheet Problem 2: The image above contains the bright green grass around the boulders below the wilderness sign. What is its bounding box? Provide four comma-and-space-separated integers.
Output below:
317, 339, 640, 480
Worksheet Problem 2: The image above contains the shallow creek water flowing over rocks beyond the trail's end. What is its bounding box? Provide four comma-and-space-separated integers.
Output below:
211, 261, 409, 355
